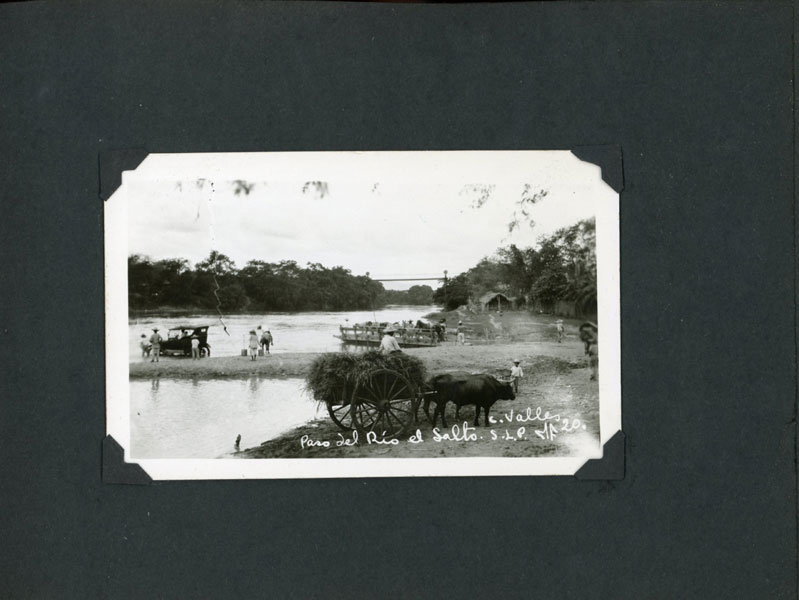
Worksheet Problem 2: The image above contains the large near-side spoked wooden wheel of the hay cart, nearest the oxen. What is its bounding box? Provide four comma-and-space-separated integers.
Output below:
350, 369, 419, 439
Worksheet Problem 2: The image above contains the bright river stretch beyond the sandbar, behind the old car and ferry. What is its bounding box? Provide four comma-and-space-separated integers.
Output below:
128, 306, 439, 360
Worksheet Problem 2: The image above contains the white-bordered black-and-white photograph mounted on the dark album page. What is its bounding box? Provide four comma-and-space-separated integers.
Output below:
105, 150, 621, 479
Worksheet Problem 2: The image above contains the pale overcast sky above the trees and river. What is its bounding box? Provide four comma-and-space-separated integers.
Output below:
127, 154, 598, 289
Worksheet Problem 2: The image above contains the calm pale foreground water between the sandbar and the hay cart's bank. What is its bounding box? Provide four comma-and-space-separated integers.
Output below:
130, 376, 324, 458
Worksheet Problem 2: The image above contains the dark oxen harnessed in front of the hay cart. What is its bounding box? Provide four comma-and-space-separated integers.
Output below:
424, 373, 516, 427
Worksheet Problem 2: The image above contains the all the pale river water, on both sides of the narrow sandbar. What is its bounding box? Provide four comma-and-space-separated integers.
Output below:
129, 306, 438, 458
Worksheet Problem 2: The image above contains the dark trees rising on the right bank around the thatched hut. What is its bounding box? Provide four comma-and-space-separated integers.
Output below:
433, 218, 597, 314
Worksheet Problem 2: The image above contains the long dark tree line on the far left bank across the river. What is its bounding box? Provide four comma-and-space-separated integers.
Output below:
128, 250, 433, 312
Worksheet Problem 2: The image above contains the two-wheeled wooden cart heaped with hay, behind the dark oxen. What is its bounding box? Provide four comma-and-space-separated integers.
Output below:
305, 351, 427, 438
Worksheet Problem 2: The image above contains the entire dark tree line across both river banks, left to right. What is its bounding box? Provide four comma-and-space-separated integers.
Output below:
128, 218, 597, 314
